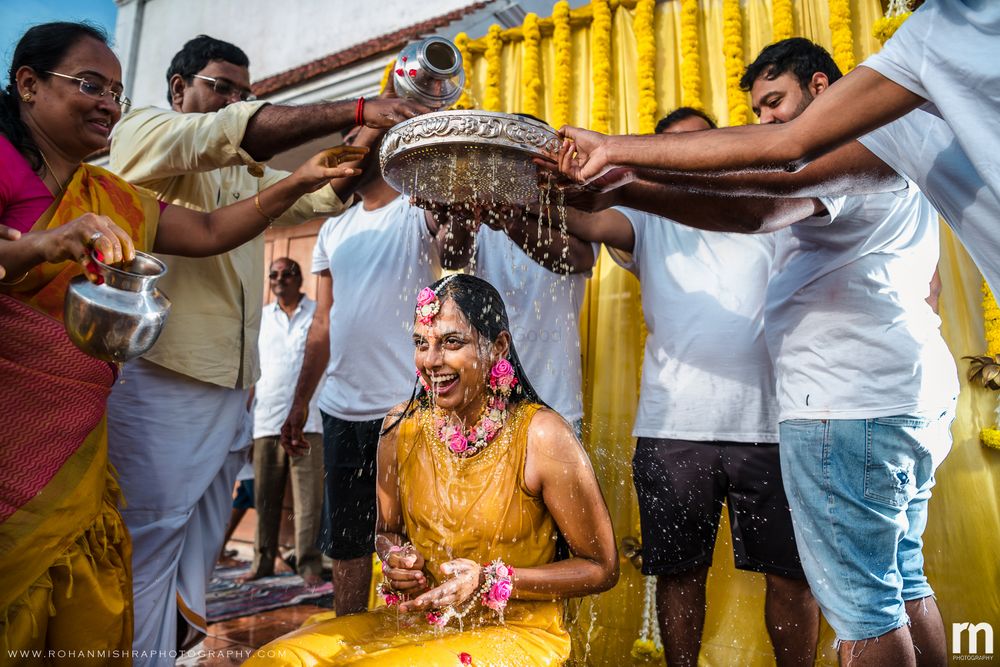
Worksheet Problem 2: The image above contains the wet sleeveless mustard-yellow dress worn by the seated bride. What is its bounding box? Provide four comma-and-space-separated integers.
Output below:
246, 403, 570, 667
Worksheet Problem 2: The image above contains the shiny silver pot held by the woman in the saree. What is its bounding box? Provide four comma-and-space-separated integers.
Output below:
63, 252, 170, 363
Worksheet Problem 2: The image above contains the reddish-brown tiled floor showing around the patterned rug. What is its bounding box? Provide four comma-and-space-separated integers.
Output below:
177, 511, 330, 667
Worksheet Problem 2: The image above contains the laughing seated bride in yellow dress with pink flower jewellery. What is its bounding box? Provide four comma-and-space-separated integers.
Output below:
247, 274, 618, 667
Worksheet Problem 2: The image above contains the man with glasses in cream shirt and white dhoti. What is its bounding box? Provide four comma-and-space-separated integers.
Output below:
108, 36, 422, 664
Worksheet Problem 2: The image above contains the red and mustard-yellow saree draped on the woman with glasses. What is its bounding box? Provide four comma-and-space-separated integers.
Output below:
0, 165, 159, 665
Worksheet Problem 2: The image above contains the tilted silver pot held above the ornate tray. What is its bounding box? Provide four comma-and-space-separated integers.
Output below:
392, 36, 465, 109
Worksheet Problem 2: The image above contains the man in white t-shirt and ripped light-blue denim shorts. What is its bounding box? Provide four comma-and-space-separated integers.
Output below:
580, 38, 958, 665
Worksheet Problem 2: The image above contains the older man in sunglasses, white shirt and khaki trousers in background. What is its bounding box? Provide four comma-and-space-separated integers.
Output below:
244, 257, 323, 585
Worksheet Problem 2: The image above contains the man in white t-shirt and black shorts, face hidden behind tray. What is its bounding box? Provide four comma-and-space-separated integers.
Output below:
282, 148, 440, 615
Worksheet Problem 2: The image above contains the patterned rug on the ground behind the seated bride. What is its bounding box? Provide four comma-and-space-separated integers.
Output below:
207, 561, 333, 623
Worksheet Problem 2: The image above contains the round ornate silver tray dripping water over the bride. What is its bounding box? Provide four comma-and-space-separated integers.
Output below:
379, 110, 560, 205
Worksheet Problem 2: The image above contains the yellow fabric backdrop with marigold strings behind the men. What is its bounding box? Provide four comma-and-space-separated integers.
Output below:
461, 0, 1000, 665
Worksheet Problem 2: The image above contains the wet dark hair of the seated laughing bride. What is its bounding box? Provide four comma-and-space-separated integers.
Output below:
382, 273, 548, 434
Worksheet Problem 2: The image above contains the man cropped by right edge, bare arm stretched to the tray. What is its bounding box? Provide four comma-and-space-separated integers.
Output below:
563, 0, 1000, 290
